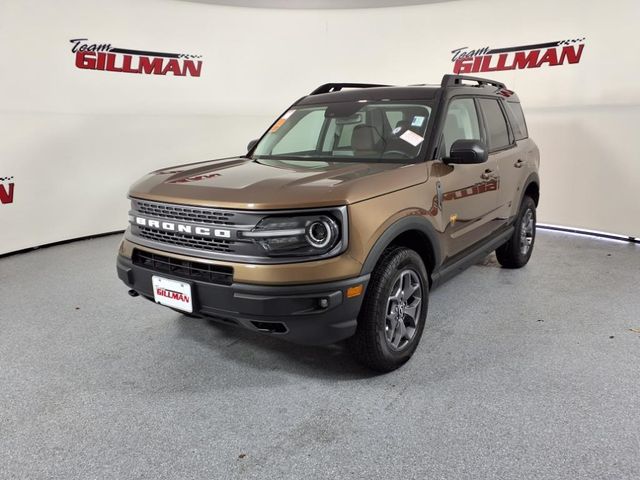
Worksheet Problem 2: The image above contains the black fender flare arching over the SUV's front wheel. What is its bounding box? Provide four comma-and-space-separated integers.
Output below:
360, 215, 442, 275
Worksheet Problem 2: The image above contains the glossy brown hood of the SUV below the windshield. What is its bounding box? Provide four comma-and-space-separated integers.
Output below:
129, 157, 427, 210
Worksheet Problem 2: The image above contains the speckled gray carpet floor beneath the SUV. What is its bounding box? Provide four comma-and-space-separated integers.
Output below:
0, 231, 640, 480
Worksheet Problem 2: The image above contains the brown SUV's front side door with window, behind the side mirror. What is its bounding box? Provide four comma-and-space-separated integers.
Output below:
437, 97, 498, 257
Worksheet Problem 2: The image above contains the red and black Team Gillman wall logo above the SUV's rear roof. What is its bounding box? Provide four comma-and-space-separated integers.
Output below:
451, 38, 585, 74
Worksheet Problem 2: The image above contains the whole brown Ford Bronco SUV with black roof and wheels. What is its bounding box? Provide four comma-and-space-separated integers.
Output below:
117, 75, 540, 371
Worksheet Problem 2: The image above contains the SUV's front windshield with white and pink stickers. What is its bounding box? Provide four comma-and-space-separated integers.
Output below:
253, 101, 431, 161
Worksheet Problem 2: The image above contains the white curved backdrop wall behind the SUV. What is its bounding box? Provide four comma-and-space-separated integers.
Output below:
0, 0, 640, 254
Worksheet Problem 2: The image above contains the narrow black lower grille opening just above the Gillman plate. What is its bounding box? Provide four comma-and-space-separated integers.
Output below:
132, 249, 233, 285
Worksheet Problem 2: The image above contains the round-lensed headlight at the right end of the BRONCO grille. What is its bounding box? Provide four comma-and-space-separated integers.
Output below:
242, 215, 340, 257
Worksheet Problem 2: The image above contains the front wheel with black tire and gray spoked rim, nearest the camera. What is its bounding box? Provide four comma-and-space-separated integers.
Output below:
348, 247, 429, 372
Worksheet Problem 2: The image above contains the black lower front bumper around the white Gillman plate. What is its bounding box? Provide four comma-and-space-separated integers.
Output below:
117, 255, 369, 345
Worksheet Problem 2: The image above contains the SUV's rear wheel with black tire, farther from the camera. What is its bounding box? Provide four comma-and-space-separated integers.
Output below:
496, 196, 536, 268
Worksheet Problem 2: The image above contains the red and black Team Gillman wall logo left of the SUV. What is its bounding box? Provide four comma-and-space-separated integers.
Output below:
69, 38, 202, 77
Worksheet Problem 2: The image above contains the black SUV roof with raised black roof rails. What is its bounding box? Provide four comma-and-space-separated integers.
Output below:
297, 75, 517, 105
